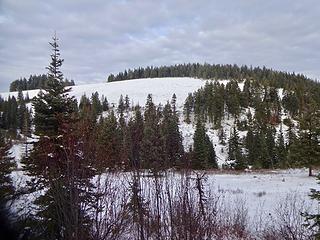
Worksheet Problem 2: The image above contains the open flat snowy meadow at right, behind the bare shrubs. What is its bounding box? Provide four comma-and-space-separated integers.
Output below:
207, 169, 319, 217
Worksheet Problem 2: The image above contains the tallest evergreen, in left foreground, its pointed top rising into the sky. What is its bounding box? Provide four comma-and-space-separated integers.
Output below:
24, 34, 92, 239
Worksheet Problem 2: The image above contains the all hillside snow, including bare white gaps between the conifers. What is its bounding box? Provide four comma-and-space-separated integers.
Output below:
0, 77, 292, 166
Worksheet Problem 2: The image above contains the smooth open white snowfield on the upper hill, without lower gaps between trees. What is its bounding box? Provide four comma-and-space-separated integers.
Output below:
0, 78, 205, 107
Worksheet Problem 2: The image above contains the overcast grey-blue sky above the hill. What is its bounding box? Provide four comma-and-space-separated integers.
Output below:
0, 0, 320, 91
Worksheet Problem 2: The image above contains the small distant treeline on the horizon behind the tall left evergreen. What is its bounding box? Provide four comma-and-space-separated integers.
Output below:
10, 74, 74, 92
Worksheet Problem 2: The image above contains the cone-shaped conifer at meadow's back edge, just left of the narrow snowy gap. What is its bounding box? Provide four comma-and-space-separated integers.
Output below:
191, 120, 218, 169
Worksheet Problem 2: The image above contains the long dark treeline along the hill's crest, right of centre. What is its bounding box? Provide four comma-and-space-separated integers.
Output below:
108, 63, 320, 102
